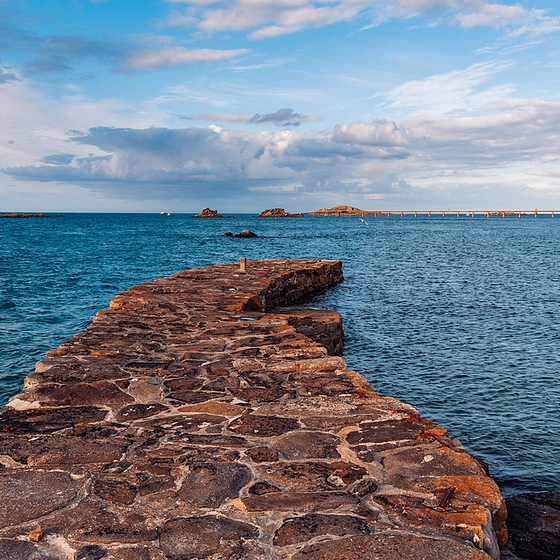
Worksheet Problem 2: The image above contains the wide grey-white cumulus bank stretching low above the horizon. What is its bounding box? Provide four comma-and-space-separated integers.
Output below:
6, 100, 560, 203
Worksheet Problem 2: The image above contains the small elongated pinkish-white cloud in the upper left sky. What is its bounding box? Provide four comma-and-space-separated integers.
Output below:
128, 47, 249, 70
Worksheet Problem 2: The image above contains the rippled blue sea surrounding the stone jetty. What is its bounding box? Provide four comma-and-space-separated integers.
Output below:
0, 214, 560, 494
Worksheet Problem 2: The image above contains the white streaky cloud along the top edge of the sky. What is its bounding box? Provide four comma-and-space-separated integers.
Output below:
167, 0, 560, 39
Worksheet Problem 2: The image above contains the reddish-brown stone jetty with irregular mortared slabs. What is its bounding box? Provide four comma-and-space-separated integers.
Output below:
0, 260, 507, 560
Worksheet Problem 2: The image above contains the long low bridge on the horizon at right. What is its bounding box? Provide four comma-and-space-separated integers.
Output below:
305, 208, 560, 218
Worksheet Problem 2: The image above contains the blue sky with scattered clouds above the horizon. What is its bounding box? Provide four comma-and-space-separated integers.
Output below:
0, 0, 560, 212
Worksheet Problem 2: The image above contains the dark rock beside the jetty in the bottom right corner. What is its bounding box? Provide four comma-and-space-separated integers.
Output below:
506, 492, 560, 560
